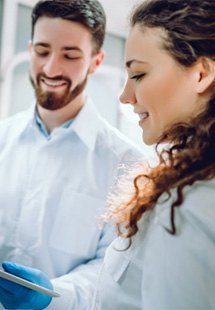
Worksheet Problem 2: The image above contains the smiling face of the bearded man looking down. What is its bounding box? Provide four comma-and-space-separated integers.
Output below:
29, 17, 101, 110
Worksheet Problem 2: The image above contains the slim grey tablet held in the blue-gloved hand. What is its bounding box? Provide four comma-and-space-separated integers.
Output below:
0, 269, 60, 297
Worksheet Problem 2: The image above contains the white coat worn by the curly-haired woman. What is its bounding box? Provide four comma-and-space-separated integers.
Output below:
92, 180, 215, 310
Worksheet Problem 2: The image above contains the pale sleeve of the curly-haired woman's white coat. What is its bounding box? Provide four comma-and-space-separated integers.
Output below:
142, 183, 215, 310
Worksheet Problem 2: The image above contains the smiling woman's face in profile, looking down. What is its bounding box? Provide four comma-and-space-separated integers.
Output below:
120, 25, 206, 144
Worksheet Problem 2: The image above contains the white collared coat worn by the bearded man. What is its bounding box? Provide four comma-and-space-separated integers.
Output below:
0, 98, 143, 310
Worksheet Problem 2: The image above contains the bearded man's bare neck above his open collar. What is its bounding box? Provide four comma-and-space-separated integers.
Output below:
37, 93, 85, 133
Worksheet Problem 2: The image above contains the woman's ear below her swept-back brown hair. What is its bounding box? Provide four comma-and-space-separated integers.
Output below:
196, 57, 215, 94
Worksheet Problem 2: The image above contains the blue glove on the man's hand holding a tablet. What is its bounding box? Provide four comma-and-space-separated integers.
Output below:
0, 262, 53, 310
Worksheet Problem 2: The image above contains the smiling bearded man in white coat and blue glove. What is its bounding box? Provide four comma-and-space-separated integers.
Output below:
0, 0, 140, 310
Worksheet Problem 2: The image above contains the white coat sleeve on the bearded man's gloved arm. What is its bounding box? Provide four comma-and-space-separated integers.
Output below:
47, 225, 114, 310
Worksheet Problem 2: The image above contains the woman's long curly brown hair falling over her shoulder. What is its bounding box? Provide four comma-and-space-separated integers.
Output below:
106, 0, 215, 238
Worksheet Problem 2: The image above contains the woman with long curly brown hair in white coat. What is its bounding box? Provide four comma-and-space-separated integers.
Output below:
93, 0, 215, 310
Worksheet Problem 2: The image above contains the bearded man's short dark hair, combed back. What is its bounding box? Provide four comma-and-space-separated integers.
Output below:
31, 0, 106, 53
